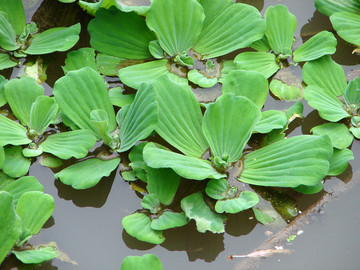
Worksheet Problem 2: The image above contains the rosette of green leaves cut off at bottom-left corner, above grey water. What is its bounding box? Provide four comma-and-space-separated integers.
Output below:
0, 176, 58, 264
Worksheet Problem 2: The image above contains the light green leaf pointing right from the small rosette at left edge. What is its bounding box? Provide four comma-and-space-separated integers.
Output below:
39, 130, 96, 159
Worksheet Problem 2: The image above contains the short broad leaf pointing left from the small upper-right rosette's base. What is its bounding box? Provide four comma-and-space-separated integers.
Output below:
234, 52, 280, 78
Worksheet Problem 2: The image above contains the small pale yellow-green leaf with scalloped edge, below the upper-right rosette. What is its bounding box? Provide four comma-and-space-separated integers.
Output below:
270, 79, 303, 101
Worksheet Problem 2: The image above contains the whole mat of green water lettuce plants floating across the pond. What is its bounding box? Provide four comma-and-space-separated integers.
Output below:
0, 0, 360, 269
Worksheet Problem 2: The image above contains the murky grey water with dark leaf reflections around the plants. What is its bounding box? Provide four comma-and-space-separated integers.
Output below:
0, 0, 360, 270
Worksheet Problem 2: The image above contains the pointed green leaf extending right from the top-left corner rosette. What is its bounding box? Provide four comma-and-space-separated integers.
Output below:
24, 23, 81, 55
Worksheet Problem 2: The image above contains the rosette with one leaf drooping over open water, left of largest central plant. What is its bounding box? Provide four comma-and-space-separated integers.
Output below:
54, 67, 158, 189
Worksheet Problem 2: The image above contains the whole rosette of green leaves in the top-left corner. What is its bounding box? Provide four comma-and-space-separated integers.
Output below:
0, 0, 80, 70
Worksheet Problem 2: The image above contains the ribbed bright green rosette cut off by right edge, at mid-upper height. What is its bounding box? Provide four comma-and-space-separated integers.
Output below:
303, 56, 360, 139
